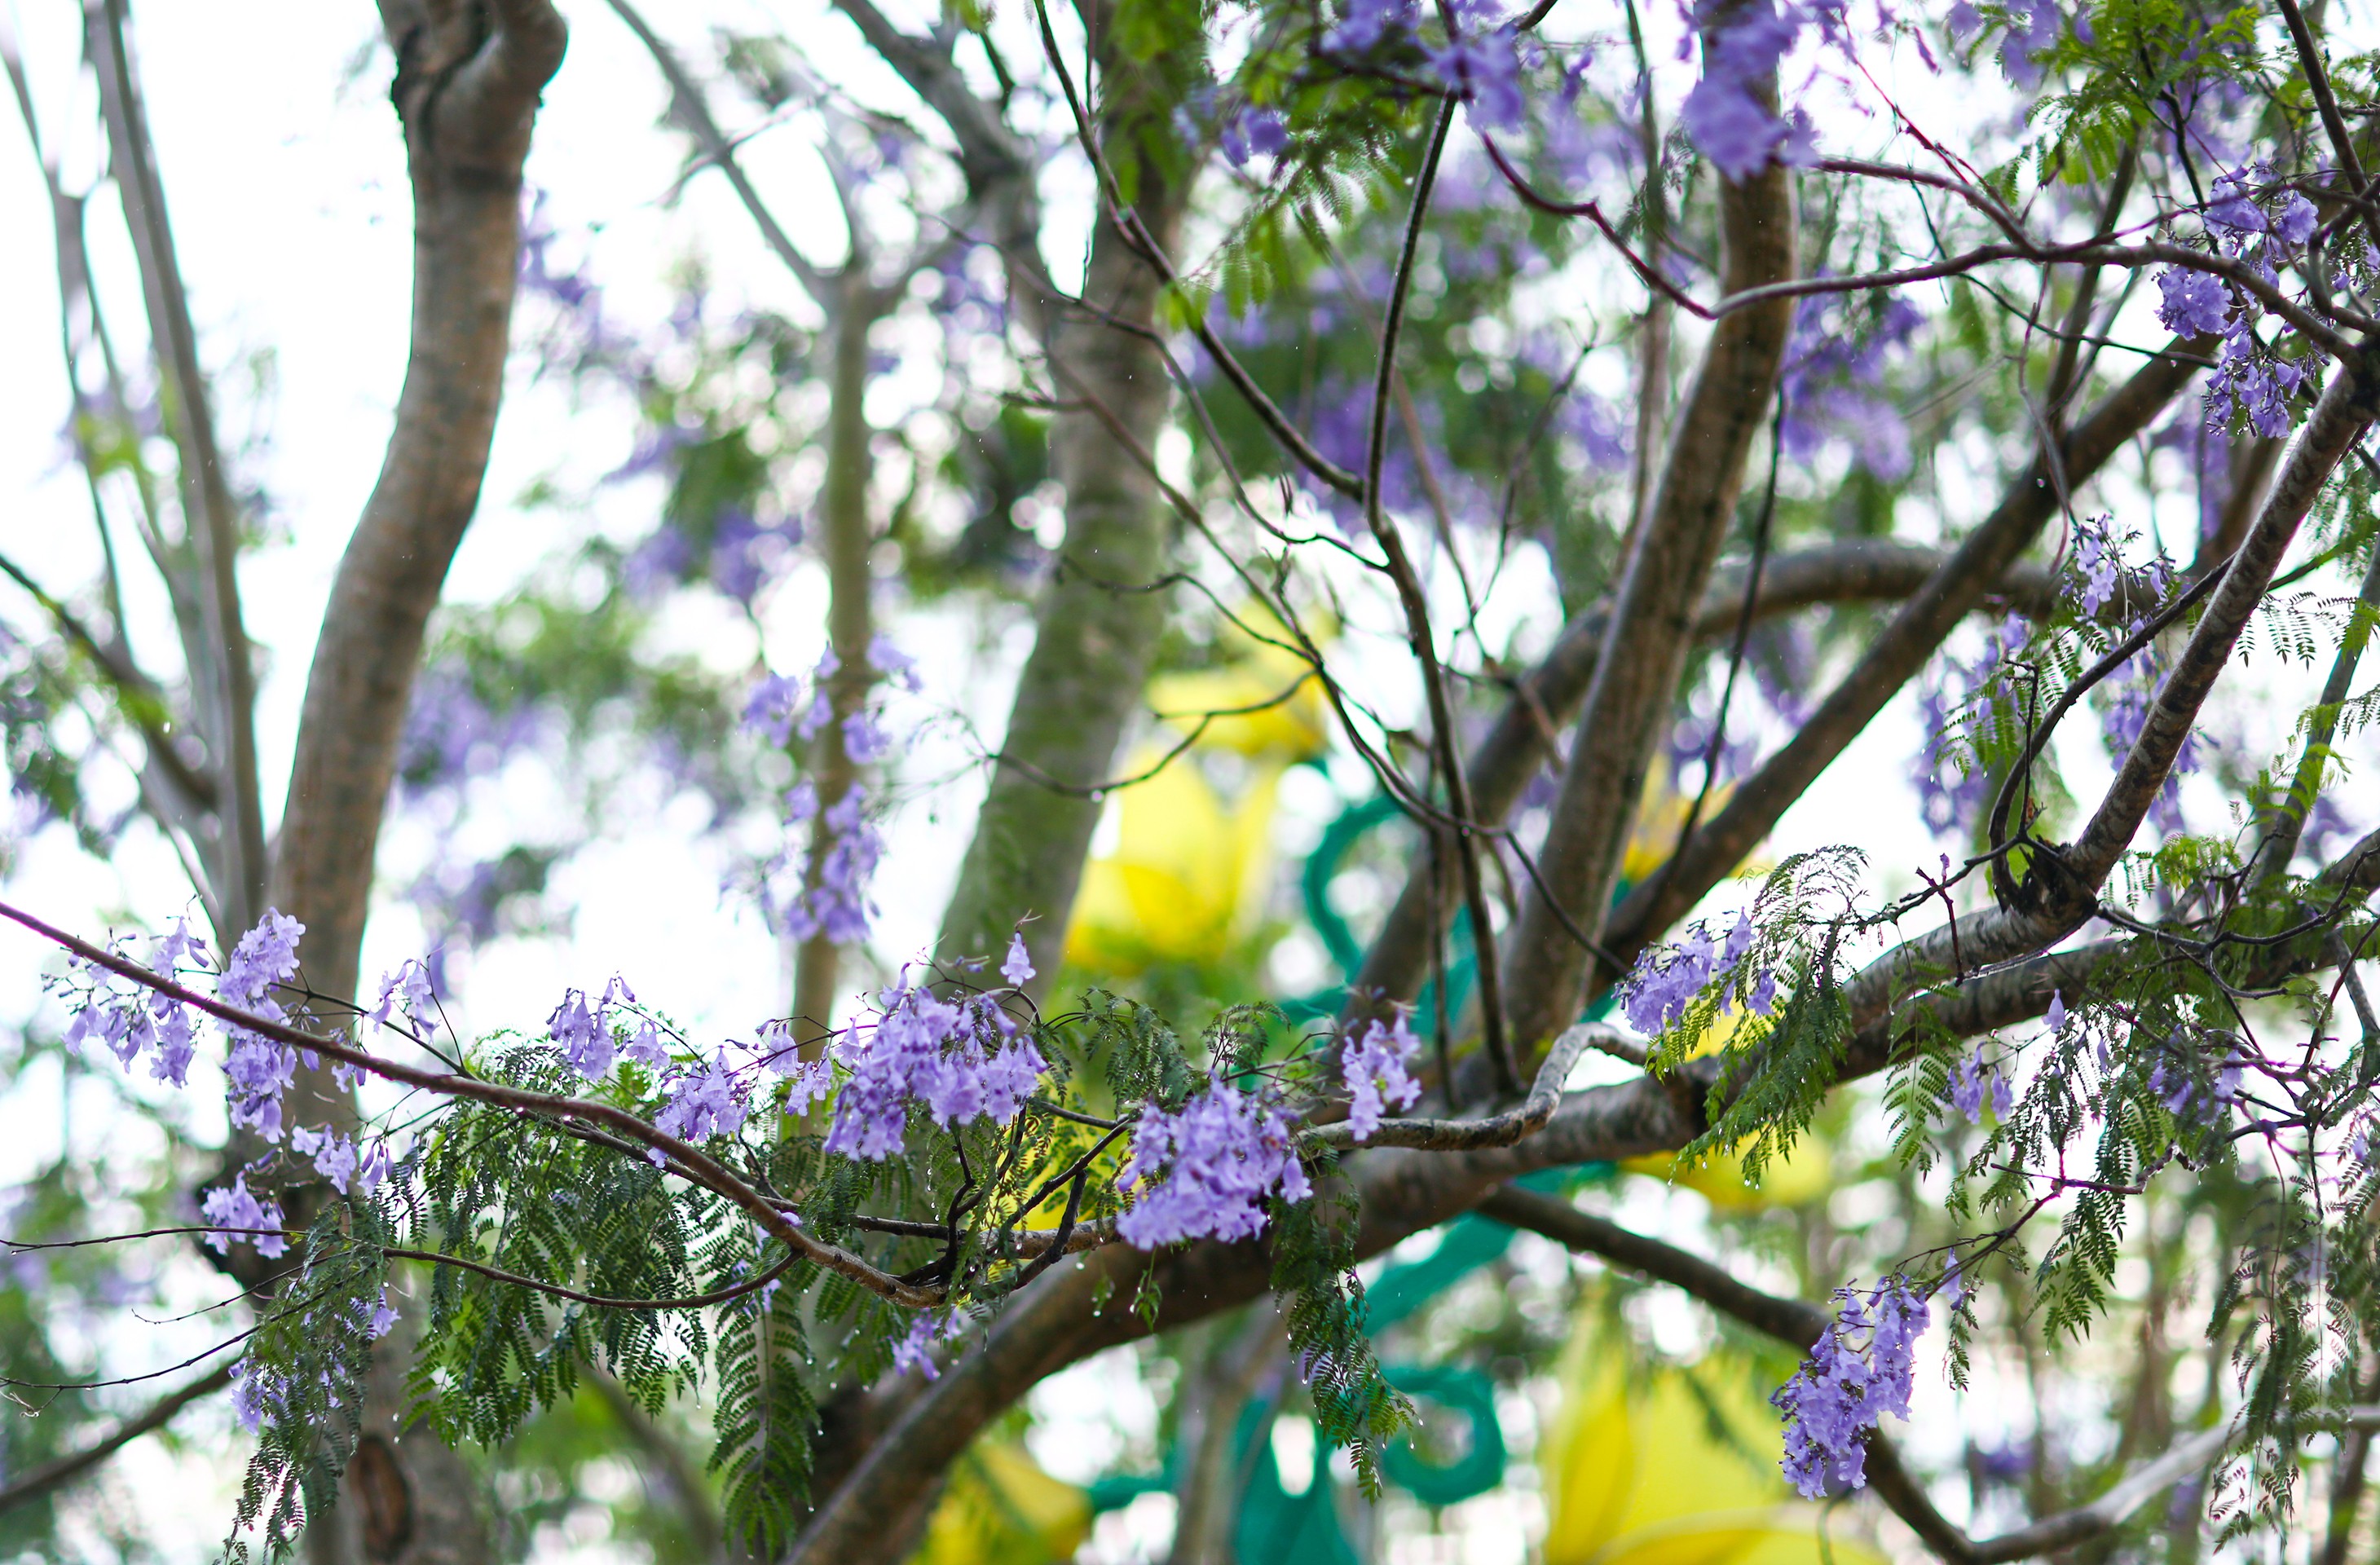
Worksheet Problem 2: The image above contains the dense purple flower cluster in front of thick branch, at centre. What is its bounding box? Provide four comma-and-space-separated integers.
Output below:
1116, 1075, 1314, 1251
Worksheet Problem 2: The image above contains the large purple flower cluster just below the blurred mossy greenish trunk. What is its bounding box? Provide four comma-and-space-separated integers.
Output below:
826, 946, 1050, 1161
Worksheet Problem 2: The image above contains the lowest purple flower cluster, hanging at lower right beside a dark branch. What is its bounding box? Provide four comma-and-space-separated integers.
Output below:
1770, 1277, 1925, 1501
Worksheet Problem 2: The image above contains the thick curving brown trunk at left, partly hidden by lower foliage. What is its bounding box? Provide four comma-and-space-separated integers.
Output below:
271, 0, 564, 1565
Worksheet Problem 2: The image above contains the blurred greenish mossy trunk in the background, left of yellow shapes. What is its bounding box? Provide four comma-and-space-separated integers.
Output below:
928, 7, 1188, 987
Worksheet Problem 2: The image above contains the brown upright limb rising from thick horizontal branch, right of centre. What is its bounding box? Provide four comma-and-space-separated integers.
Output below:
1504, 83, 1795, 1065
